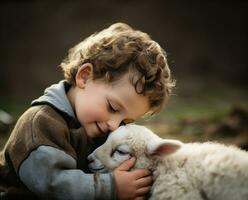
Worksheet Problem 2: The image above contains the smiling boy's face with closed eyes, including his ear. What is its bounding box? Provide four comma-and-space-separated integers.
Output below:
68, 64, 150, 138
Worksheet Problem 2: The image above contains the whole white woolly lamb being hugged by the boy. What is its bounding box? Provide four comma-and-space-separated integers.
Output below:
88, 124, 248, 200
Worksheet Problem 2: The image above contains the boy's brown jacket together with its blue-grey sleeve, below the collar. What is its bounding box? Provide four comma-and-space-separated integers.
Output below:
0, 80, 115, 200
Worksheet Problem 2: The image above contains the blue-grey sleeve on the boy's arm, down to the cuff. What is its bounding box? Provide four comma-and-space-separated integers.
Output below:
19, 146, 115, 200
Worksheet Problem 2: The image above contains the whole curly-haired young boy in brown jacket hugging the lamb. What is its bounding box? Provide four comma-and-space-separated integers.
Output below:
0, 23, 173, 200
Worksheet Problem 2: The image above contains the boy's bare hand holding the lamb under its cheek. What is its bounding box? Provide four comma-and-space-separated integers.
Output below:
114, 158, 152, 200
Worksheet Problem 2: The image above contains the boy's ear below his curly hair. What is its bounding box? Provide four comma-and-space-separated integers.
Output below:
75, 63, 93, 88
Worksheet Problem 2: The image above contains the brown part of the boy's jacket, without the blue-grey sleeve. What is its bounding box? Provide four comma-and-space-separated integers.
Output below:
0, 105, 92, 199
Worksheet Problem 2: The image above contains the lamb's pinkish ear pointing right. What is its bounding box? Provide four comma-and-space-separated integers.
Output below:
147, 138, 183, 156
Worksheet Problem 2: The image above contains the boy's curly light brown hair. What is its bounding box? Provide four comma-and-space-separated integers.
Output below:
60, 23, 175, 114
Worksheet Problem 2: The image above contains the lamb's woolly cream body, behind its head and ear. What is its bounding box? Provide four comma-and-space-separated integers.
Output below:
151, 143, 248, 200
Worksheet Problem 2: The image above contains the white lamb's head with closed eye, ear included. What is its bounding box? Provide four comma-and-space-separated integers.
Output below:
88, 124, 182, 172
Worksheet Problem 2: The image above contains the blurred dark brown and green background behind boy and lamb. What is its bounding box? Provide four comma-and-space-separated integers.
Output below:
0, 0, 248, 149
